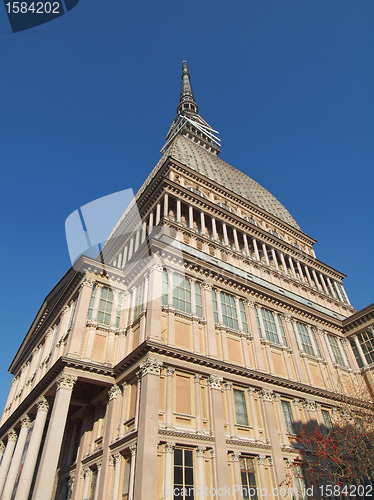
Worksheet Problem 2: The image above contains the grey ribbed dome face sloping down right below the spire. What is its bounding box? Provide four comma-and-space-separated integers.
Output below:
166, 135, 300, 229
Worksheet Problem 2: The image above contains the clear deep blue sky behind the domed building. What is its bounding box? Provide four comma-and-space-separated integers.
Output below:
0, 0, 374, 407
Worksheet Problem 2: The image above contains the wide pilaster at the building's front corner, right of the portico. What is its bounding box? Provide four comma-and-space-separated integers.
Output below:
134, 358, 162, 500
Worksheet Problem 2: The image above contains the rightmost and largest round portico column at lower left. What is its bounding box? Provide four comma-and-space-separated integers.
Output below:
32, 373, 77, 500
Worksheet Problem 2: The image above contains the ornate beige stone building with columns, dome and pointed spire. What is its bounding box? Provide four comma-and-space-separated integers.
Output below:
0, 62, 374, 500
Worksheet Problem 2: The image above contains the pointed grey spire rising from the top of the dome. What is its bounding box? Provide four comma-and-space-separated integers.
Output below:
161, 61, 221, 155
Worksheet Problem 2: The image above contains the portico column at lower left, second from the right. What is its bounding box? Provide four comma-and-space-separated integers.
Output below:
15, 396, 49, 500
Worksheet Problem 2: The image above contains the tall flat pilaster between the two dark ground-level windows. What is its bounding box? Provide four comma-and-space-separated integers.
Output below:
207, 375, 230, 492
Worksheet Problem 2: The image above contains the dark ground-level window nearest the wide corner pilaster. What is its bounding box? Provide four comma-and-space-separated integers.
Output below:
174, 448, 194, 500
